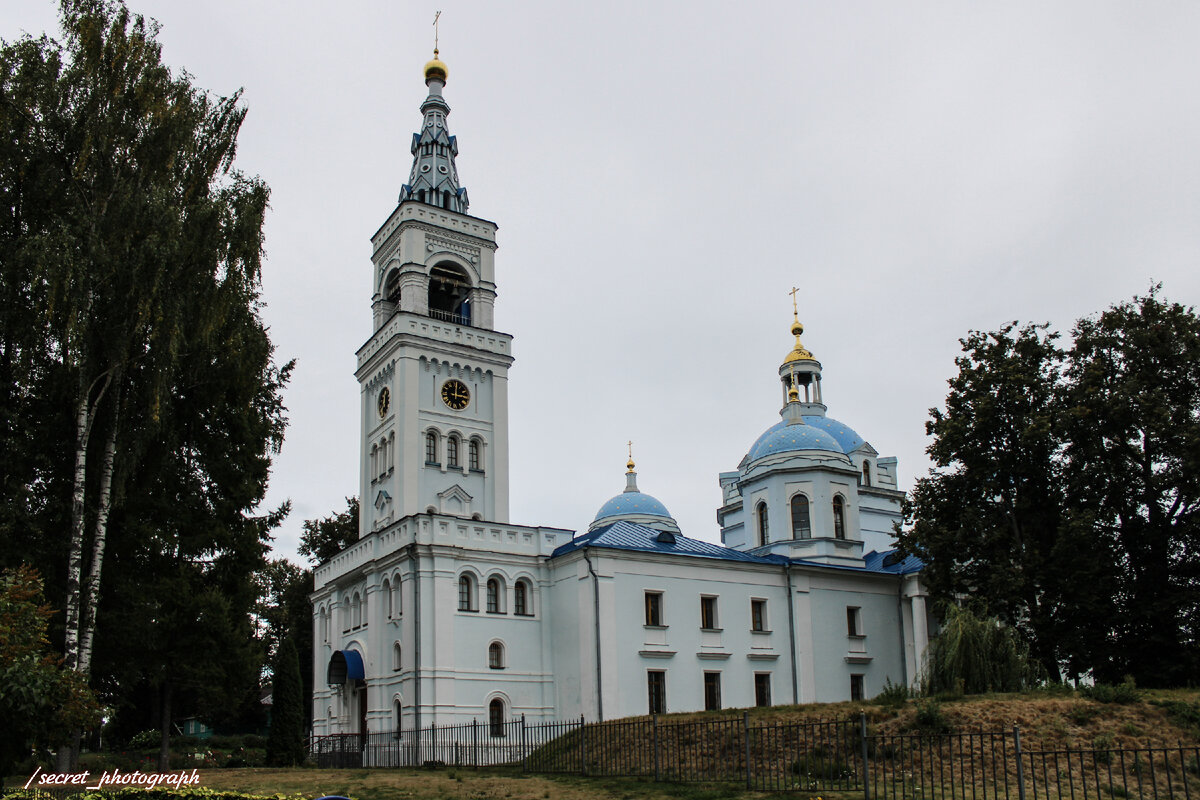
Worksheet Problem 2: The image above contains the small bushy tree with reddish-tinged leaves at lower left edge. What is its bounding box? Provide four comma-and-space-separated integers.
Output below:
0, 566, 100, 788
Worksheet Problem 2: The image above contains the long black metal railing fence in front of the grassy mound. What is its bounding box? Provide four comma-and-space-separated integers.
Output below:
310, 714, 1200, 800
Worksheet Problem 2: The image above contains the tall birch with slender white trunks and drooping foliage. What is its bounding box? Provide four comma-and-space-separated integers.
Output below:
0, 0, 287, 762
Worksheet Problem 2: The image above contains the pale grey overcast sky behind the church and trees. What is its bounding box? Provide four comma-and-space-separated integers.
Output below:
0, 0, 1200, 563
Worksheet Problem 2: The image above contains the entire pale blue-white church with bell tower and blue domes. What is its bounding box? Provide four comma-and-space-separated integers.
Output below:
312, 52, 930, 735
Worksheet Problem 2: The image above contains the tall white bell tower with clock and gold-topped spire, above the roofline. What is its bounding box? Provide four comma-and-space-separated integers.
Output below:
355, 49, 512, 536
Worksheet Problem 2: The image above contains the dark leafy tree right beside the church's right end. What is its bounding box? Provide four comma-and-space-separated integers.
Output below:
899, 323, 1062, 674
